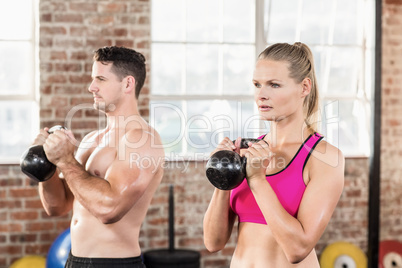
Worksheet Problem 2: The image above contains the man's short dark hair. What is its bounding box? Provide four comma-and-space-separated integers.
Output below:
93, 46, 146, 99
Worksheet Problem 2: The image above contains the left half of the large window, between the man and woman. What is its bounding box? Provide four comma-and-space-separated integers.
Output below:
150, 0, 259, 159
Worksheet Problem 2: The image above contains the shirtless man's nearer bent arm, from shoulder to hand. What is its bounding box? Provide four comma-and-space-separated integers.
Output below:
44, 130, 163, 224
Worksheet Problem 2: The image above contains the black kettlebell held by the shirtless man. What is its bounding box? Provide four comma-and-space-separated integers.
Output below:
20, 125, 66, 182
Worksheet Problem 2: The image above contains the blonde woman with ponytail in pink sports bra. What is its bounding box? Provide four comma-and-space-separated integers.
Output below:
204, 42, 344, 268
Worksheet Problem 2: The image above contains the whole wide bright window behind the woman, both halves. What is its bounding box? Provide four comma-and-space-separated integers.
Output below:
150, 0, 374, 159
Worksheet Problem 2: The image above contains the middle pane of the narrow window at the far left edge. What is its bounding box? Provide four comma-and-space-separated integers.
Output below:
0, 41, 34, 95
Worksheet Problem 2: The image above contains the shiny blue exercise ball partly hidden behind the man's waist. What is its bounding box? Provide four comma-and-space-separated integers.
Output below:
46, 228, 71, 268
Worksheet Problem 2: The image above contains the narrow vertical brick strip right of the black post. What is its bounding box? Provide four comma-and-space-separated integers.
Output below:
380, 0, 402, 242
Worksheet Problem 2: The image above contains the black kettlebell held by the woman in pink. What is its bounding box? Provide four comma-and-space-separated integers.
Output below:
206, 139, 261, 190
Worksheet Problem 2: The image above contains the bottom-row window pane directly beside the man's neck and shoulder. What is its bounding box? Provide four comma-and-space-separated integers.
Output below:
150, 101, 185, 155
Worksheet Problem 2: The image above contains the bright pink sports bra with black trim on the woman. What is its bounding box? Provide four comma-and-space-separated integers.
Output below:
230, 133, 323, 224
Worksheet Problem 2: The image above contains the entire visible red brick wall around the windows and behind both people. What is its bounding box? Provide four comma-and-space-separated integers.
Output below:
0, 0, 402, 268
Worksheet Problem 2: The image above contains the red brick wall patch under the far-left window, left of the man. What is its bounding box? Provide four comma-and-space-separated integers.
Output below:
0, 165, 69, 268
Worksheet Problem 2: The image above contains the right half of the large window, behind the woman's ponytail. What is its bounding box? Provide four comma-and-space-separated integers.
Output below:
260, 0, 375, 156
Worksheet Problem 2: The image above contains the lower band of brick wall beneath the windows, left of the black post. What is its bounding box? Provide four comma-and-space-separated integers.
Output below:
0, 159, 368, 268
